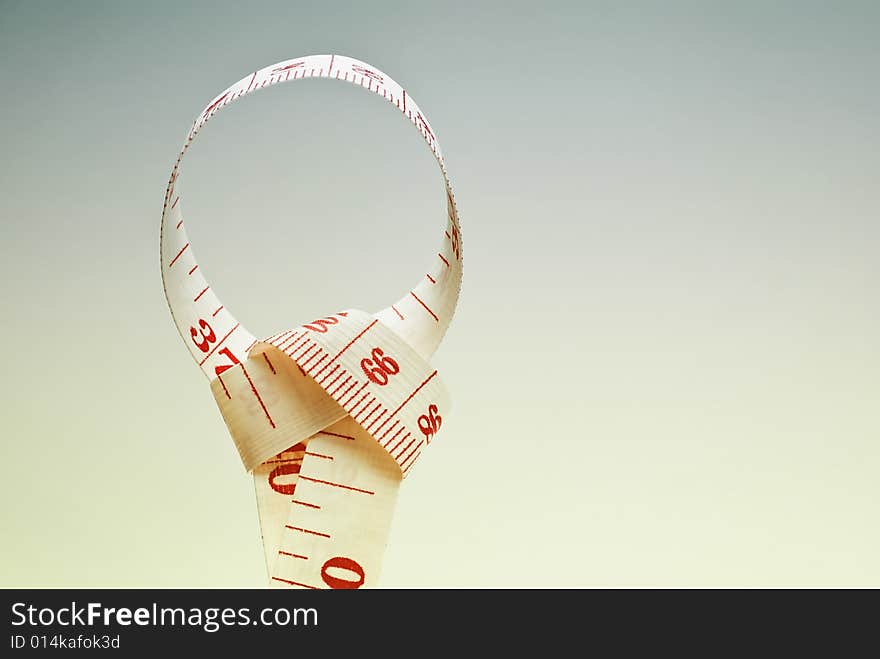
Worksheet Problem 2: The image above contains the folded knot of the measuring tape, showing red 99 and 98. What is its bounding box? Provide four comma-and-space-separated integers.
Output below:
211, 310, 449, 476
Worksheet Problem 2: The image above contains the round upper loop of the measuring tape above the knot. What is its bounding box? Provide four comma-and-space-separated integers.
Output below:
160, 55, 462, 379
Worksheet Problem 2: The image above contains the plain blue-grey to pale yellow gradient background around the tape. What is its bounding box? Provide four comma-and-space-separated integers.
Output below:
0, 0, 880, 587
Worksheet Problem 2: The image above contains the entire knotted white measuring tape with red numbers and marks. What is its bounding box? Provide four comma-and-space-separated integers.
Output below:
160, 55, 462, 588
